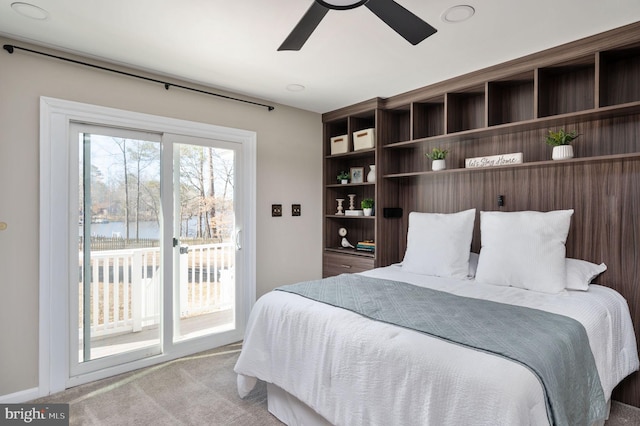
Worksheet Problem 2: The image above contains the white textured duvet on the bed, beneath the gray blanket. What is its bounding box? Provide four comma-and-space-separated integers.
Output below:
235, 266, 638, 426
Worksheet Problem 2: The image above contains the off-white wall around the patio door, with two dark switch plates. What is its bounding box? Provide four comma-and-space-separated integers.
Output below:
0, 37, 322, 398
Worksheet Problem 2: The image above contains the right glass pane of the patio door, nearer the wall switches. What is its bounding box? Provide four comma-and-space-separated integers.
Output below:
174, 144, 235, 340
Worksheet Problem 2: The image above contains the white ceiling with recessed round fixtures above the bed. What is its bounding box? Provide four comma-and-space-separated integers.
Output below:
0, 0, 640, 113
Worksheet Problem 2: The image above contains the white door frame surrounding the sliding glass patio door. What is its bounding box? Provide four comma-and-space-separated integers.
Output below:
38, 97, 257, 396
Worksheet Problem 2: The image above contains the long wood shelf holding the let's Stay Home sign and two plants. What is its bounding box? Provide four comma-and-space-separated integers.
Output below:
383, 152, 640, 179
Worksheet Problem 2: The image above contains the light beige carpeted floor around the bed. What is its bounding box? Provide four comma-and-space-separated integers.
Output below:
33, 343, 640, 426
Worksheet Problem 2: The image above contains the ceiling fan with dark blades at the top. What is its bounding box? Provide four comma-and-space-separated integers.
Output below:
278, 0, 437, 50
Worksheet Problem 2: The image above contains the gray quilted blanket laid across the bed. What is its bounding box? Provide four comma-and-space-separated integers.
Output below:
276, 274, 606, 426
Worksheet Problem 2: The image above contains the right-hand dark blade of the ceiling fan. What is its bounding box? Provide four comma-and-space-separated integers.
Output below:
364, 0, 438, 45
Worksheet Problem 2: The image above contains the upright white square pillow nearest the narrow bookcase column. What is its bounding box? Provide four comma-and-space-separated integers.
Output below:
402, 209, 476, 278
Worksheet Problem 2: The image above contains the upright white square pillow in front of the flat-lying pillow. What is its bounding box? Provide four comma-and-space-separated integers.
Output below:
476, 210, 573, 293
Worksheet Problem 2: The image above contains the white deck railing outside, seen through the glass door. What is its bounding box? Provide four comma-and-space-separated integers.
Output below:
80, 243, 235, 337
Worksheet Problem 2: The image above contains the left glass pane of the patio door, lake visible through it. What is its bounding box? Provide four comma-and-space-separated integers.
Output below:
78, 133, 162, 363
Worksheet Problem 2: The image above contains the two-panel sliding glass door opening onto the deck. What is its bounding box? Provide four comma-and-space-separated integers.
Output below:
69, 124, 242, 377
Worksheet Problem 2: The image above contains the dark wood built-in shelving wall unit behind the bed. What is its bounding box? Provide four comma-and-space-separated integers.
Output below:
323, 23, 640, 406
